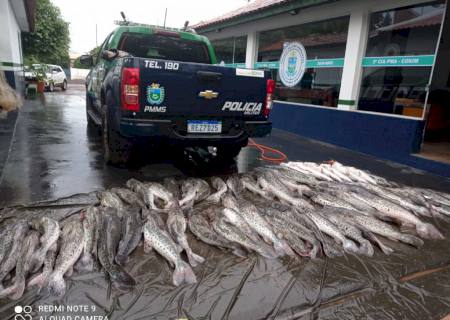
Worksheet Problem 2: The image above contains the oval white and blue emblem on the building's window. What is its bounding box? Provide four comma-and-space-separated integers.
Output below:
278, 42, 306, 87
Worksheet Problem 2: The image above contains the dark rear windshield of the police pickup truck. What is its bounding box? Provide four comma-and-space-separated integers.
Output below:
118, 33, 211, 63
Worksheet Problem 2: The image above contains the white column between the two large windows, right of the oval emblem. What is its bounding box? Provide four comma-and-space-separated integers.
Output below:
338, 8, 370, 110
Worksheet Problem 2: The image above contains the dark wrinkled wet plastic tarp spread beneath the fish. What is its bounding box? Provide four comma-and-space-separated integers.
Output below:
0, 194, 450, 320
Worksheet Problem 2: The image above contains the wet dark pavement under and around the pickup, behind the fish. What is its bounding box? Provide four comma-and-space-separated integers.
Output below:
0, 84, 450, 207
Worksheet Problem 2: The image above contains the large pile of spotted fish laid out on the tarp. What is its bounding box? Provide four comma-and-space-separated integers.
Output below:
0, 161, 450, 299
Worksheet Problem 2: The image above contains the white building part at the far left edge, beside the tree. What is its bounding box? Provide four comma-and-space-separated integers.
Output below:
0, 0, 36, 91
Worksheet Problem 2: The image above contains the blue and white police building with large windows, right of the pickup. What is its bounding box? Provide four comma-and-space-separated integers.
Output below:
195, 0, 450, 175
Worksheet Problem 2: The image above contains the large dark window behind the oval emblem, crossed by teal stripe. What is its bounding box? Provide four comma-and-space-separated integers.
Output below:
256, 17, 349, 107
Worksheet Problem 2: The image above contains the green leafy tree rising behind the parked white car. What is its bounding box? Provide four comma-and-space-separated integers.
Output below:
22, 0, 70, 67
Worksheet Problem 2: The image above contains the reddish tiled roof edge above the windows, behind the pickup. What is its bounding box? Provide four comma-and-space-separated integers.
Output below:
194, 0, 338, 33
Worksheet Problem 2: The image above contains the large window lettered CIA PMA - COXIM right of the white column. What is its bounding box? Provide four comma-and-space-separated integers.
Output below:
358, 1, 445, 118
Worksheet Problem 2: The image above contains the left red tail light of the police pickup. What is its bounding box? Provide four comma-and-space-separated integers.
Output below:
121, 68, 139, 111
